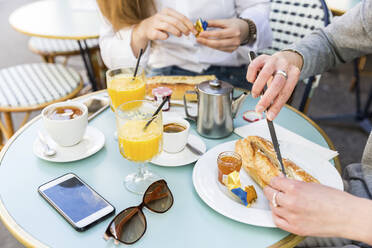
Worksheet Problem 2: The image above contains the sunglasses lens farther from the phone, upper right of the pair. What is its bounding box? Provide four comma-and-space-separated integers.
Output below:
144, 180, 173, 213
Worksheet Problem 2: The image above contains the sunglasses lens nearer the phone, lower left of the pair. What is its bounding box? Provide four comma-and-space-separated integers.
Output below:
109, 207, 146, 244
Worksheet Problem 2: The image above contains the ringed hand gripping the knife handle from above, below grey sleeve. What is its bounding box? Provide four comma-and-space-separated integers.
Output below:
247, 51, 303, 120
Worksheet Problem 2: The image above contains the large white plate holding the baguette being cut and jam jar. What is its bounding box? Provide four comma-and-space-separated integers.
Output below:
193, 141, 343, 227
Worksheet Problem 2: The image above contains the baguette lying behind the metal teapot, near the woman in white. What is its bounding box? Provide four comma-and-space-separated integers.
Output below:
146, 75, 216, 101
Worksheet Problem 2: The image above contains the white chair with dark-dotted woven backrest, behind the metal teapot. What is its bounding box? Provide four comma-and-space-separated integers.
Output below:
259, 0, 332, 113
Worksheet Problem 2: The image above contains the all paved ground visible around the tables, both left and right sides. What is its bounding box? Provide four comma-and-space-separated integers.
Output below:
0, 0, 372, 248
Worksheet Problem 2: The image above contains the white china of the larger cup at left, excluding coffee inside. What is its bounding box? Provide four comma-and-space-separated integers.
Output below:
41, 101, 88, 146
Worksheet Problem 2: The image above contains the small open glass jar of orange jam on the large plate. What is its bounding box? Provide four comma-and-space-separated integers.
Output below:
217, 151, 242, 184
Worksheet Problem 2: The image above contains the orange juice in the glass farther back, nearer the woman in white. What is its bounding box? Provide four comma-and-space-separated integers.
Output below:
107, 76, 146, 109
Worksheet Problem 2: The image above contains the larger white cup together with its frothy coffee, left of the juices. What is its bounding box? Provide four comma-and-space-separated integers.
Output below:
41, 101, 88, 146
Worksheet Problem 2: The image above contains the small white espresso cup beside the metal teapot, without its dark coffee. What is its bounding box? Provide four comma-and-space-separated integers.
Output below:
163, 117, 190, 153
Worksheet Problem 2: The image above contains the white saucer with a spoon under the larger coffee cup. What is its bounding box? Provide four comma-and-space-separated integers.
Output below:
33, 126, 105, 162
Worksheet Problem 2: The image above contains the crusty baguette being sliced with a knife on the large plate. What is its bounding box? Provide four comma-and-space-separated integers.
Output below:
235, 136, 319, 188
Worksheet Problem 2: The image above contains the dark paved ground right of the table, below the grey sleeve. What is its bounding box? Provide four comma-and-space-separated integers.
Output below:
294, 62, 372, 166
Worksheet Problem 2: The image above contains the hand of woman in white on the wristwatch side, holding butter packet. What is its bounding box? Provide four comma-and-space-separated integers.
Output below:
196, 18, 249, 53
